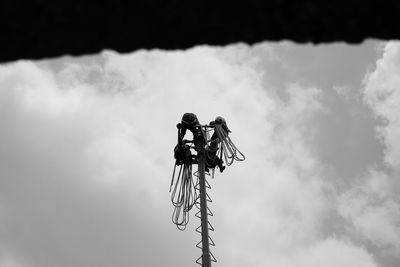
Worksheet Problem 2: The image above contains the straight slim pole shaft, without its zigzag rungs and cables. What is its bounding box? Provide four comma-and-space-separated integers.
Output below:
197, 148, 211, 267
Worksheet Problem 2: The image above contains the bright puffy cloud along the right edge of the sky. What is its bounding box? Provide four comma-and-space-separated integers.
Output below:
339, 42, 400, 259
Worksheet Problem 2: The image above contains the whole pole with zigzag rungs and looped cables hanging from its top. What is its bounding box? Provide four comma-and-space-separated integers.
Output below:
170, 113, 245, 267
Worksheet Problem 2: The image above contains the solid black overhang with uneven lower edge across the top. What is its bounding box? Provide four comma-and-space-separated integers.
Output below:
0, 0, 400, 62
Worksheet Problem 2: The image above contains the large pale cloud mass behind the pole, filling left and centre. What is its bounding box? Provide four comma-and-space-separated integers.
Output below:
0, 46, 386, 267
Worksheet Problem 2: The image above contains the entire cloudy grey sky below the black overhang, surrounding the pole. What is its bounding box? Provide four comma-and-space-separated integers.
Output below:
0, 40, 400, 267
